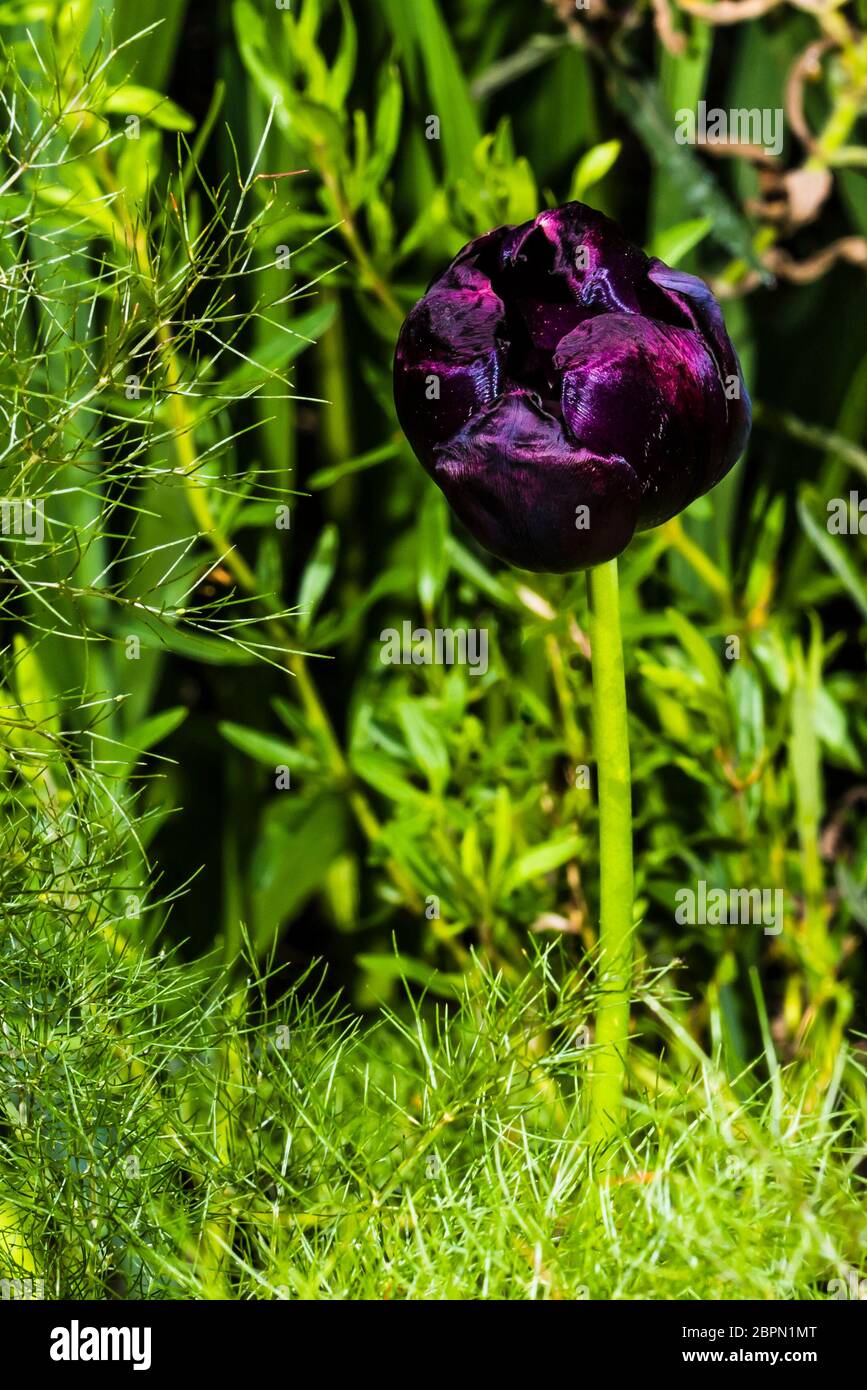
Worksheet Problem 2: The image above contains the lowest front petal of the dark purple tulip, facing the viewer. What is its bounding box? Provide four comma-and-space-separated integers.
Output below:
434, 391, 641, 573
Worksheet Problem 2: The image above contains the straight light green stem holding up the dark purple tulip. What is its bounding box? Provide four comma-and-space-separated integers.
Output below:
588, 560, 634, 1148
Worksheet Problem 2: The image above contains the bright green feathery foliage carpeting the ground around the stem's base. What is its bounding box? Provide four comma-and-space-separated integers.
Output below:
0, 799, 867, 1300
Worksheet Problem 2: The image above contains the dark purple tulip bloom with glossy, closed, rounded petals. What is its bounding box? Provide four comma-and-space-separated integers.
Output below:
395, 203, 750, 573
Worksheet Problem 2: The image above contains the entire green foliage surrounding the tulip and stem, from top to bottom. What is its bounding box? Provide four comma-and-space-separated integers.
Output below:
0, 0, 867, 1298
